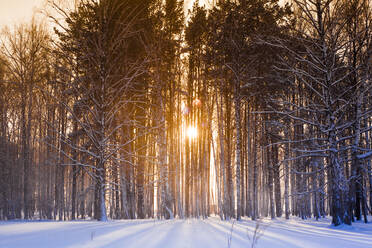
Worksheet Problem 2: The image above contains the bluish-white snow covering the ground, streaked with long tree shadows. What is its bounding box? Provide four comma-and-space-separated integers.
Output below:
0, 217, 372, 248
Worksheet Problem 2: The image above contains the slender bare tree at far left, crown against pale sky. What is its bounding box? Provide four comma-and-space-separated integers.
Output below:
1, 20, 48, 219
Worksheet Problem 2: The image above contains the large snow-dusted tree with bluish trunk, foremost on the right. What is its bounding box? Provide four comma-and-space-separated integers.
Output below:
266, 0, 370, 225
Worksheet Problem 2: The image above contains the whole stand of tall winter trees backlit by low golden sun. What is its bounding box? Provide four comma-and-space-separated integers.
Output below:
0, 0, 372, 226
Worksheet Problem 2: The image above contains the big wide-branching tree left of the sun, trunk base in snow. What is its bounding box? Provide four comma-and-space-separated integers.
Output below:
52, 0, 144, 221
